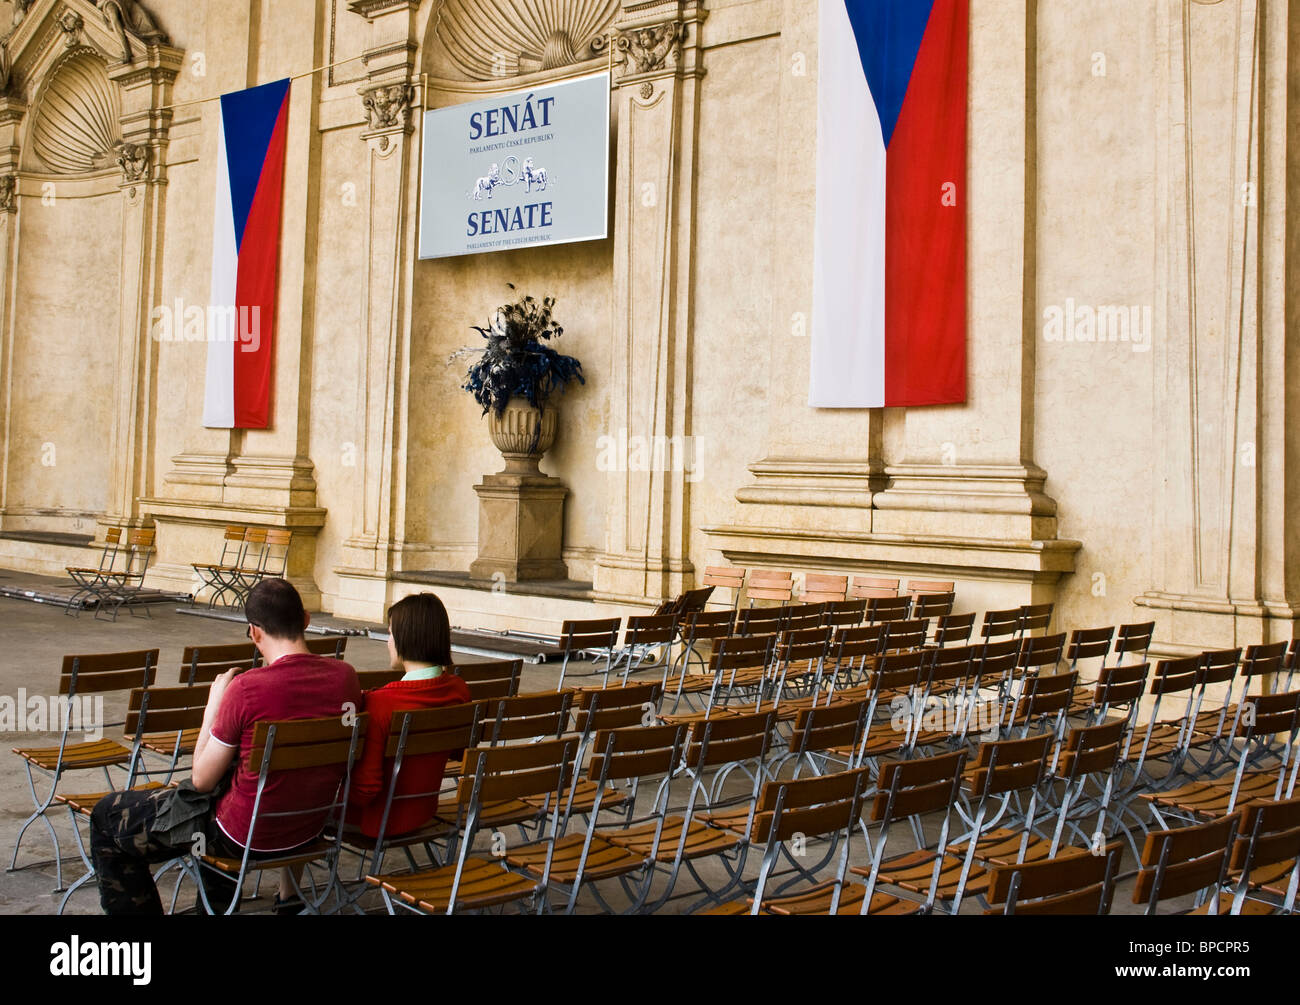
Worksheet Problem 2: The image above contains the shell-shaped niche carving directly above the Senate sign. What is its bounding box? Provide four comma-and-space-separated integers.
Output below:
438, 0, 619, 81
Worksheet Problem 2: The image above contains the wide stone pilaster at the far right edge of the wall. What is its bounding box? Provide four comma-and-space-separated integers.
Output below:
1138, 0, 1300, 653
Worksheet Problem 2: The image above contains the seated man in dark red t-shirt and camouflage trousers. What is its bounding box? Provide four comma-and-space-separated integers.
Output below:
91, 580, 361, 914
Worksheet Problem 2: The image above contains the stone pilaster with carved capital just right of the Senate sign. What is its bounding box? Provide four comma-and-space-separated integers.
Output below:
595, 0, 706, 601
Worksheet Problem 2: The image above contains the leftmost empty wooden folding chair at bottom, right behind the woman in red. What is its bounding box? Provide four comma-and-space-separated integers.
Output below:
365, 738, 577, 914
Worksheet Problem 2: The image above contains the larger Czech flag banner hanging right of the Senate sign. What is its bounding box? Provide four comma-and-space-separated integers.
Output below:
809, 0, 969, 408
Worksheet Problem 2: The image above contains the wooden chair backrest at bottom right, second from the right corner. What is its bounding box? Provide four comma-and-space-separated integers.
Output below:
1134, 813, 1242, 914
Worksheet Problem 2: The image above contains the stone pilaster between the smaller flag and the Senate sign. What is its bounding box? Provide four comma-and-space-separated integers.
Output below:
335, 0, 424, 618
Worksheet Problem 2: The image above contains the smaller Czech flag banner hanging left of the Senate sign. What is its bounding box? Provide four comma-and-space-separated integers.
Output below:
203, 79, 289, 429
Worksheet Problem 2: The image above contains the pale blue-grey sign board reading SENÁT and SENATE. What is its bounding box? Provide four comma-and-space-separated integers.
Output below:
420, 73, 610, 259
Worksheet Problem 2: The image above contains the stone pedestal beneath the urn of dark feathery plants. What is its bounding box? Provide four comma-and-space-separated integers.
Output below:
469, 471, 568, 582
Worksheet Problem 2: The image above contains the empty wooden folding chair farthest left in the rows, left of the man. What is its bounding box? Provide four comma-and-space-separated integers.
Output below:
9, 649, 159, 891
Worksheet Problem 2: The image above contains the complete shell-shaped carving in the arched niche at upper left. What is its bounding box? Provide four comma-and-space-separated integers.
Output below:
30, 51, 122, 174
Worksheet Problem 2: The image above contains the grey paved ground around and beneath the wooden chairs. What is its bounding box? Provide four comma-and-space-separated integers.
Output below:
0, 572, 1227, 914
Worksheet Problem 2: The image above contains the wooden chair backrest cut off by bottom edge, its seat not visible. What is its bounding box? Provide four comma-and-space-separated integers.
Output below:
984, 841, 1123, 914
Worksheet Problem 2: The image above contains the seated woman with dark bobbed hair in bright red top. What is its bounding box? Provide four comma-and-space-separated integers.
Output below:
347, 593, 469, 837
